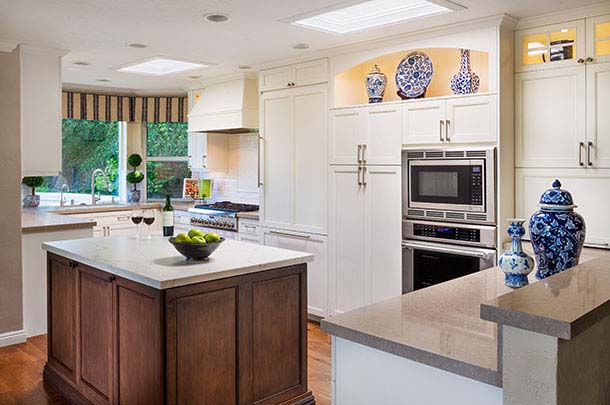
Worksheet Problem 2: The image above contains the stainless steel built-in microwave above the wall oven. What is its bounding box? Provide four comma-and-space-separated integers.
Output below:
402, 148, 496, 224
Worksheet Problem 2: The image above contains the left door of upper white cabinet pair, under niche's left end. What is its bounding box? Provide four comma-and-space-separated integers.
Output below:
329, 108, 365, 165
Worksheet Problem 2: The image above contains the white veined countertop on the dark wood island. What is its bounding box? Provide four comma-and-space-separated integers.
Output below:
42, 236, 314, 289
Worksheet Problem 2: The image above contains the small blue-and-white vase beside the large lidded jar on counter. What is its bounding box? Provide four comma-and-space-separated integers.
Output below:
498, 218, 534, 288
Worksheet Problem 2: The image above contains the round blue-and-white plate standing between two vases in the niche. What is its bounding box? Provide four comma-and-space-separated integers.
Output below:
396, 51, 434, 97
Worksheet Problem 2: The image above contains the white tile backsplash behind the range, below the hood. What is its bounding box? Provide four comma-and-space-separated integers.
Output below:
193, 133, 260, 204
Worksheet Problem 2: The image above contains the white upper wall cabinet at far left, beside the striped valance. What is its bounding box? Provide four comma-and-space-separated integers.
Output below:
20, 45, 65, 176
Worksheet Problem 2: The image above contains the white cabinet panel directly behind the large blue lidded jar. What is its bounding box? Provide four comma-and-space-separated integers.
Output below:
515, 168, 610, 247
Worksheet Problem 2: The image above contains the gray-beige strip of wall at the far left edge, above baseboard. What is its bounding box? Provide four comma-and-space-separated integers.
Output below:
0, 50, 23, 338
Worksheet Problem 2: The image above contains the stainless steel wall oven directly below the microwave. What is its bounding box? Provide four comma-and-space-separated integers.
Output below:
402, 220, 496, 294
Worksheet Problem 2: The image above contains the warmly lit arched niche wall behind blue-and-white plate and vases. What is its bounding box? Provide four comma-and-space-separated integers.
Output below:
333, 48, 489, 107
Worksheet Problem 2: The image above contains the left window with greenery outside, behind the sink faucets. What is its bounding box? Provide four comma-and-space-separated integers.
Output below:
36, 119, 121, 205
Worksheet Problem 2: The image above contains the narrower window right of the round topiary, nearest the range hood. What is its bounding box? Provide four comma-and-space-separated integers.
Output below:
145, 122, 191, 199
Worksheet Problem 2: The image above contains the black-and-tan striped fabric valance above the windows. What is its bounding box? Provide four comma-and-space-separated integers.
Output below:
62, 91, 187, 122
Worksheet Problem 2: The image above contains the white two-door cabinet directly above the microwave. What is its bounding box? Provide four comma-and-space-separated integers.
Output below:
402, 95, 498, 145
